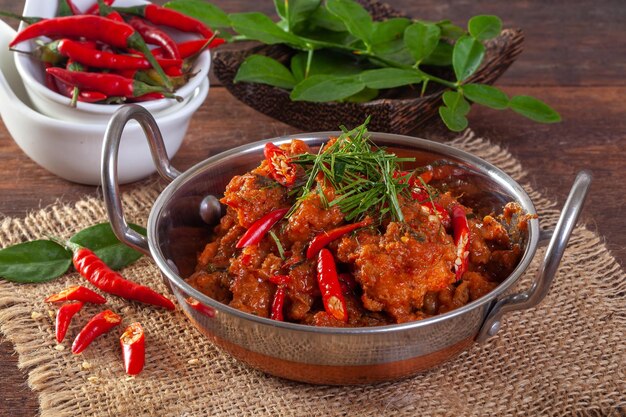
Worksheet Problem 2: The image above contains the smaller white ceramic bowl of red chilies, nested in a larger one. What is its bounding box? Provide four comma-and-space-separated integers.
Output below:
11, 0, 211, 122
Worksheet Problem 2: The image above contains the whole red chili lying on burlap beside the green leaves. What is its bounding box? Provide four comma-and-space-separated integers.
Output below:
57, 237, 175, 310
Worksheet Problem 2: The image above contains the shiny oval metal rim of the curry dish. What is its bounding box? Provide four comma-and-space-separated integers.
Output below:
147, 131, 540, 335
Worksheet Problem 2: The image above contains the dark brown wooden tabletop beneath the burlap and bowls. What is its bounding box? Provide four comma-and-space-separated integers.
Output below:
0, 0, 626, 416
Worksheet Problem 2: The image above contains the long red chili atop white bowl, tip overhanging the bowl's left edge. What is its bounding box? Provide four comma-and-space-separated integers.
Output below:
9, 15, 172, 89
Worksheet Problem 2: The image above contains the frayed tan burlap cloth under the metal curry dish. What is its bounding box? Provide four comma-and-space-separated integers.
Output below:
0, 133, 626, 417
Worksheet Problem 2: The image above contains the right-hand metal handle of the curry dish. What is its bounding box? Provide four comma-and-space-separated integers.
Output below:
476, 171, 592, 342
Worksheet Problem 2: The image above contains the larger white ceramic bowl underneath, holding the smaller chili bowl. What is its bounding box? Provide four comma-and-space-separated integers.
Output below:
0, 21, 209, 185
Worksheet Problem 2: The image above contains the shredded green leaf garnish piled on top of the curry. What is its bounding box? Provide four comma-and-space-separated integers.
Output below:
290, 118, 414, 222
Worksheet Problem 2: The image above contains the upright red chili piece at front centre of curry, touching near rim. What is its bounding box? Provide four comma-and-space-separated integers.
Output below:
317, 248, 348, 323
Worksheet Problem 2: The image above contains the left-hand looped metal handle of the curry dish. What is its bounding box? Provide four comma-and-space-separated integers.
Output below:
102, 104, 180, 255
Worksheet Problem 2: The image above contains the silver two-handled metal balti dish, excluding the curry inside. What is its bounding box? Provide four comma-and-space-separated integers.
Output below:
102, 105, 591, 384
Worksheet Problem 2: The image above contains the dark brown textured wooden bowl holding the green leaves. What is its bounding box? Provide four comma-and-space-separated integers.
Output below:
213, 0, 524, 134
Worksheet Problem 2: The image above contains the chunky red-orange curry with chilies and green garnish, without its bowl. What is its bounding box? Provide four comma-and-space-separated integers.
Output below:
188, 124, 533, 327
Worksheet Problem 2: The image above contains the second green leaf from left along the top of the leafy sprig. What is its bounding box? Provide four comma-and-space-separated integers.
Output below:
228, 12, 306, 48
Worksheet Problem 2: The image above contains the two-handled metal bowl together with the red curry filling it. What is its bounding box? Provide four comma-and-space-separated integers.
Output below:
102, 105, 591, 384
